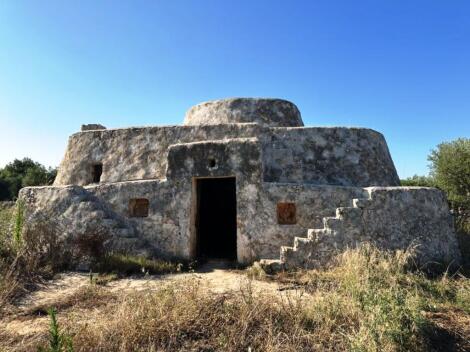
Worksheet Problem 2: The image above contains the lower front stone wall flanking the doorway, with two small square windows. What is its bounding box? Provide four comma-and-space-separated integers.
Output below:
20, 182, 370, 263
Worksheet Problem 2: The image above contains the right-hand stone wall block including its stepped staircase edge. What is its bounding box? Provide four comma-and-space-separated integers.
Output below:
281, 187, 461, 268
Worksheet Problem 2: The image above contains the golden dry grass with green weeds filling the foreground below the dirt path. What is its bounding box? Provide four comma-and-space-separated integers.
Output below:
11, 246, 470, 351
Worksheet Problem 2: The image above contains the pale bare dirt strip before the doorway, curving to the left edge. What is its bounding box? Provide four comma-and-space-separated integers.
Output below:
0, 263, 304, 351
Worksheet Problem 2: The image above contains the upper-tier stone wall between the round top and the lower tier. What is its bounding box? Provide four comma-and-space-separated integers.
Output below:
54, 124, 399, 186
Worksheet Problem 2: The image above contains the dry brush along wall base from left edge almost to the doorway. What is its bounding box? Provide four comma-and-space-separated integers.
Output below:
0, 206, 188, 312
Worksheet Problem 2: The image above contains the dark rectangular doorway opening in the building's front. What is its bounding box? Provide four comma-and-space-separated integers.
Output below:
196, 177, 237, 260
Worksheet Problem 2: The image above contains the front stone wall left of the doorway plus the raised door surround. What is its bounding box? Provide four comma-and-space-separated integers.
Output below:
20, 138, 268, 262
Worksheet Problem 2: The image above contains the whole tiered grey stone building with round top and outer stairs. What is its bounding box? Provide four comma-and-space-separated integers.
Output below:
20, 98, 459, 267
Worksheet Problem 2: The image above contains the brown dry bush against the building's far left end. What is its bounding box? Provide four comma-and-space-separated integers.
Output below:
0, 206, 112, 310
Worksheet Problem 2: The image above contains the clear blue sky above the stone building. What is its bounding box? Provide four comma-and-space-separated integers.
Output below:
0, 0, 470, 177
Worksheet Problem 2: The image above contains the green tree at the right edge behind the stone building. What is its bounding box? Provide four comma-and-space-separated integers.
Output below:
428, 138, 470, 230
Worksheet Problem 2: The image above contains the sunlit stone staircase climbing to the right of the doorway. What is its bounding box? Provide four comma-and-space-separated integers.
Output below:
260, 198, 371, 273
